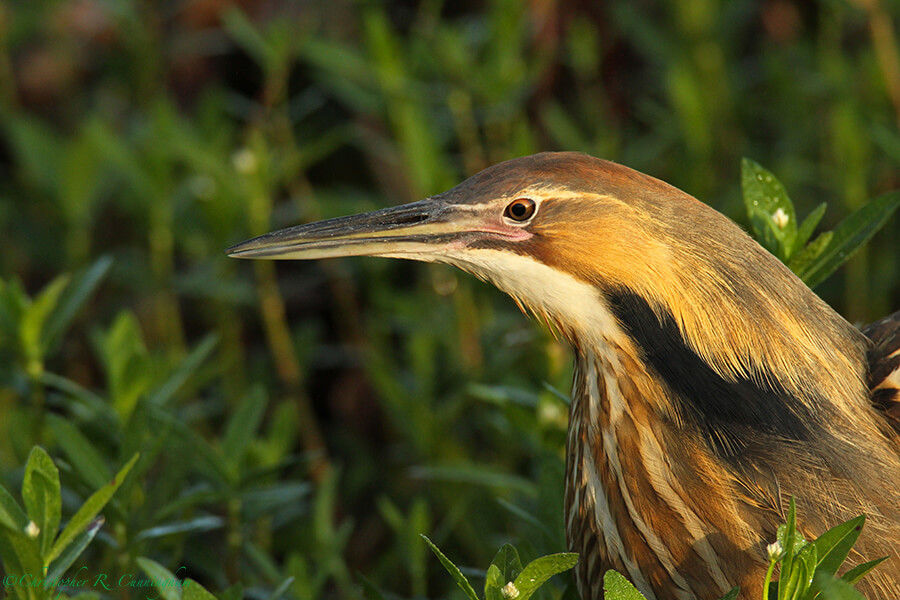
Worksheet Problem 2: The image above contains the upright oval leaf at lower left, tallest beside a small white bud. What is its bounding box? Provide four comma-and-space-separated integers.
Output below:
22, 446, 62, 556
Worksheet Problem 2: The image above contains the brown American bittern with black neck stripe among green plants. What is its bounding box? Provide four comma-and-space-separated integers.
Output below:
229, 153, 900, 600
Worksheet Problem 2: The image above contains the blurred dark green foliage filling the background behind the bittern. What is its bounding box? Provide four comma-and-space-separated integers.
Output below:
0, 0, 900, 599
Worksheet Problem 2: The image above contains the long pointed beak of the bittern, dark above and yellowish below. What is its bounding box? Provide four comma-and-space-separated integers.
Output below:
225, 197, 480, 260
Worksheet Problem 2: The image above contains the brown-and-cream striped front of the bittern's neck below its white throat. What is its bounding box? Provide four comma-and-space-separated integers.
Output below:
566, 348, 765, 600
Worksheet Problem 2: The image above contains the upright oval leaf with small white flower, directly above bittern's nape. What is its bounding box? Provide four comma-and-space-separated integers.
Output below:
741, 158, 797, 261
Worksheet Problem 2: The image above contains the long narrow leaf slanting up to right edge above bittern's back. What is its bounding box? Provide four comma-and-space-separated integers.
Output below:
801, 191, 900, 288
